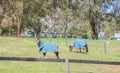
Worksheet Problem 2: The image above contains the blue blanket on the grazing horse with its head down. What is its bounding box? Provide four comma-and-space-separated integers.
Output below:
71, 39, 88, 48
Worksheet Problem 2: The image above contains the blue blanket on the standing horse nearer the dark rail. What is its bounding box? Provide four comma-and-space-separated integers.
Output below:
38, 40, 58, 53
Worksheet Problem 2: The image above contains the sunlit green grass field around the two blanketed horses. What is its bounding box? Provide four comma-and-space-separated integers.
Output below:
0, 37, 120, 73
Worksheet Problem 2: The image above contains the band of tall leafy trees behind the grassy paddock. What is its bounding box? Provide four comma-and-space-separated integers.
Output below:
0, 0, 119, 39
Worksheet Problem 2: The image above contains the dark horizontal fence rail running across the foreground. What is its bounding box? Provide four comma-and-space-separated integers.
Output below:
0, 57, 120, 65
